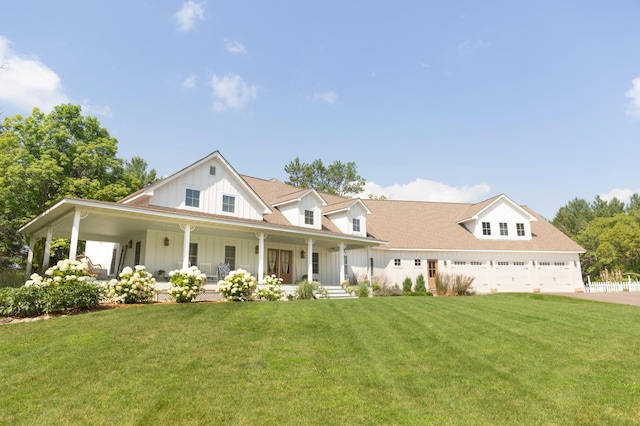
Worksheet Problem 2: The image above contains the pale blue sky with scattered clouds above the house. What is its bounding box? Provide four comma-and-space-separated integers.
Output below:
0, 0, 640, 219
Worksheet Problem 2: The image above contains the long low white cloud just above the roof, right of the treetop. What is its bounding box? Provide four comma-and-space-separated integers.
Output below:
360, 178, 491, 203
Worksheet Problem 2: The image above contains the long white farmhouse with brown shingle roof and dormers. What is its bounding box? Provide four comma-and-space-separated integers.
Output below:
20, 151, 584, 293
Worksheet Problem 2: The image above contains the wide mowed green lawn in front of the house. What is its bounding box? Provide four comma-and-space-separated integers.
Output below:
0, 294, 640, 425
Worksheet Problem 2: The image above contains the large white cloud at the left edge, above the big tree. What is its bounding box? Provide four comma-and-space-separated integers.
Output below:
0, 36, 69, 112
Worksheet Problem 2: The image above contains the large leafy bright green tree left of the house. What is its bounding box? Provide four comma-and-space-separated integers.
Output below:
0, 104, 152, 266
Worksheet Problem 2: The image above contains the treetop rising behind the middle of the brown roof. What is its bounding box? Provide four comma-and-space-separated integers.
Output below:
284, 157, 365, 197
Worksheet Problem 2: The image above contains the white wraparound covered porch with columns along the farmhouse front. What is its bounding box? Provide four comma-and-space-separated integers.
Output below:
20, 198, 379, 285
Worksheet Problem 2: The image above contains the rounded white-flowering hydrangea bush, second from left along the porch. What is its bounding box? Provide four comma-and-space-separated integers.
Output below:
105, 265, 156, 303
